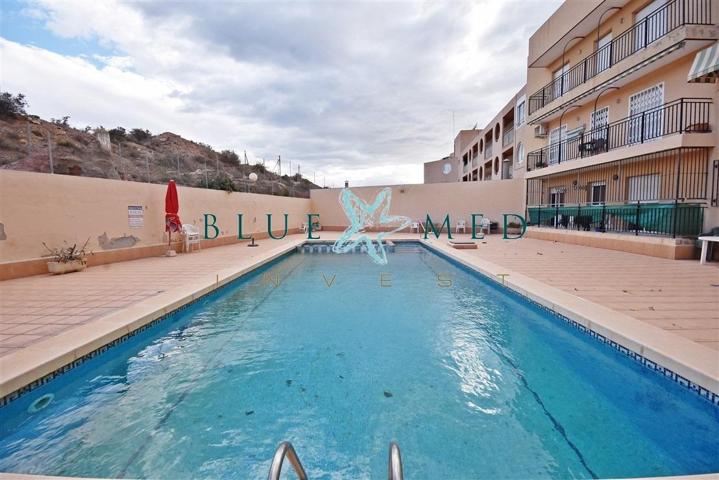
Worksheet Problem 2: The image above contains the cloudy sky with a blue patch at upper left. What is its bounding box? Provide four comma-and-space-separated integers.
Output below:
0, 0, 561, 186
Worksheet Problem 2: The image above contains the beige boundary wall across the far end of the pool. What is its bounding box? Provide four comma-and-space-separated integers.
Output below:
310, 179, 524, 229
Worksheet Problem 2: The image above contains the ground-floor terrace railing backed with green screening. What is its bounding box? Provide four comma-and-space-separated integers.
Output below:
527, 202, 704, 237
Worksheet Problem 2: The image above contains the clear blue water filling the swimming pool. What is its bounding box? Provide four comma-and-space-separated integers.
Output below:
0, 244, 719, 479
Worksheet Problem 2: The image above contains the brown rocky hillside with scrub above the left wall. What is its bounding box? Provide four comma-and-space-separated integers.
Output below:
0, 115, 319, 197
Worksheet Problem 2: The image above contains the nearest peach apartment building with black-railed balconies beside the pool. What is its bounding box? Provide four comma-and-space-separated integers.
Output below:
522, 0, 719, 238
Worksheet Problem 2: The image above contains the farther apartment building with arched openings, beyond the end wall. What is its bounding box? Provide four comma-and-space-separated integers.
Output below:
454, 88, 527, 182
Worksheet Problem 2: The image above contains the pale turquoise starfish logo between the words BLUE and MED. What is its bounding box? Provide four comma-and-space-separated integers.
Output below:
332, 188, 412, 265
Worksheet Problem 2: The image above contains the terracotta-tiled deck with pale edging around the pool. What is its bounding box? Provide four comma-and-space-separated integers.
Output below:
0, 232, 719, 402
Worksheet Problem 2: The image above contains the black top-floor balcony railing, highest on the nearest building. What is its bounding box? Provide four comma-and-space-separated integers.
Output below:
529, 0, 712, 115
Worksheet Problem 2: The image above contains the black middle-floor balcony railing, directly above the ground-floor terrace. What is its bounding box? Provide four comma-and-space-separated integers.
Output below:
527, 98, 712, 171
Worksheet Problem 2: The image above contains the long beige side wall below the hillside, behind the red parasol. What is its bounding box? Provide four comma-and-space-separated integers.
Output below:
0, 170, 310, 262
